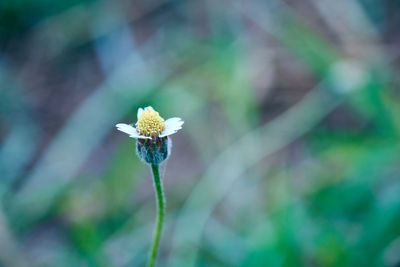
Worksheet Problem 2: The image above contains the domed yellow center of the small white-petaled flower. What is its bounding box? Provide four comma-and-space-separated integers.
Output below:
136, 109, 165, 137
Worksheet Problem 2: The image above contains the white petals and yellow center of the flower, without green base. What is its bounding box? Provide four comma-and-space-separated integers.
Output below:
115, 106, 183, 139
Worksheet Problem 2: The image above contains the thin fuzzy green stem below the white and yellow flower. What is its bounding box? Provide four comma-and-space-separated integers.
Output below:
147, 165, 165, 267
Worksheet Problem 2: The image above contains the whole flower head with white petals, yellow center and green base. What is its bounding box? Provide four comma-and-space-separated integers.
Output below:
115, 107, 183, 166
